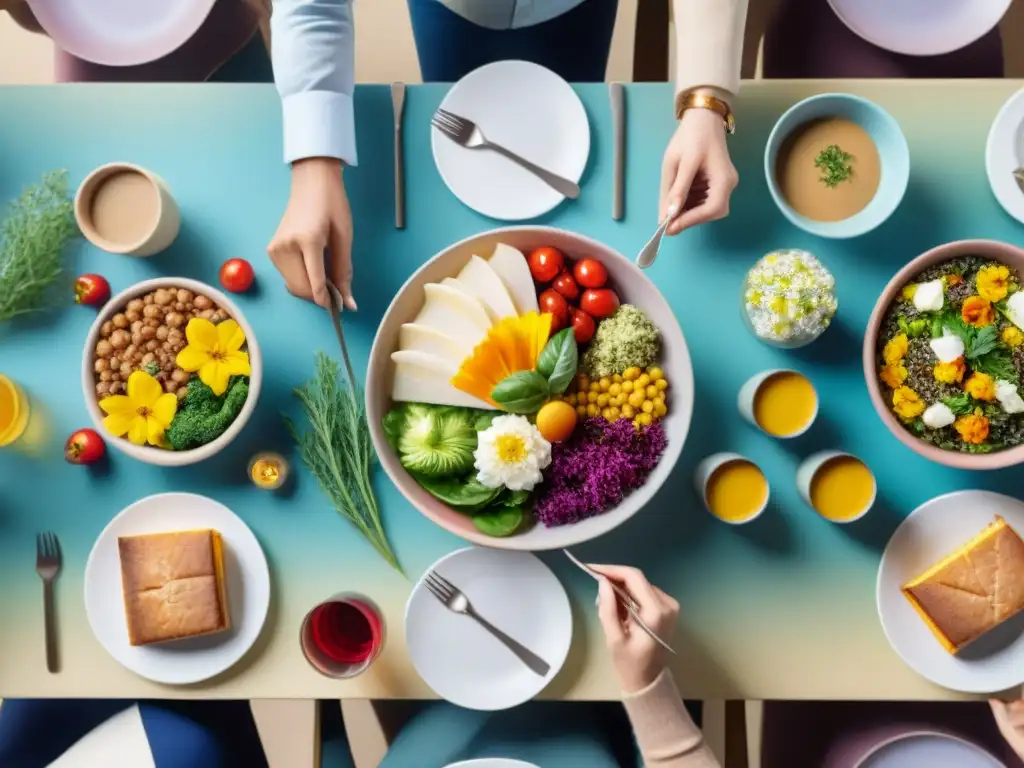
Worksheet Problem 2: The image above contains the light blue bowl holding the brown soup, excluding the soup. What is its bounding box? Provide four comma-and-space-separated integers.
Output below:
765, 93, 910, 239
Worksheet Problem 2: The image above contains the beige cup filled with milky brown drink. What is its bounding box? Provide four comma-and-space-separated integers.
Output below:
75, 163, 181, 256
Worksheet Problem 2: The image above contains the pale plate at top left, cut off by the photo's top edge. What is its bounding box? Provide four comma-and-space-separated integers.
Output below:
28, 0, 215, 67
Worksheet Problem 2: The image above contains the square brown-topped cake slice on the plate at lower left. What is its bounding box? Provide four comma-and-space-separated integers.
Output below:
118, 529, 231, 645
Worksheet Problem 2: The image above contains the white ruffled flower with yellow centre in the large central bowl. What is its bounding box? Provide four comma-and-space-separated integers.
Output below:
473, 416, 551, 490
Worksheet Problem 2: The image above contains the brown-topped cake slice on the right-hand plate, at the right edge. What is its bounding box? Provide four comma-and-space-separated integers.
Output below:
903, 517, 1024, 653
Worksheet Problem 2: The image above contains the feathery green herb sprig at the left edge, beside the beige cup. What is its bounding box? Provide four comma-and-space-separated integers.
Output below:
0, 171, 78, 323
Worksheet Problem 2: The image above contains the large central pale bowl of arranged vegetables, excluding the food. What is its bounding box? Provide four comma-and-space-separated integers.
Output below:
366, 226, 693, 551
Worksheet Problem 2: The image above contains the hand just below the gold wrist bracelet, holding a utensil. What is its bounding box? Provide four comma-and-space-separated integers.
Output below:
657, 99, 739, 234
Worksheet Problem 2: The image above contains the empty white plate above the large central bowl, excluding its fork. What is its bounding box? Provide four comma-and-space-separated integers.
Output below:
430, 60, 590, 221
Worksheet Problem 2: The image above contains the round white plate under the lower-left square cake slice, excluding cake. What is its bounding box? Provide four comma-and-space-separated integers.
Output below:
85, 494, 270, 685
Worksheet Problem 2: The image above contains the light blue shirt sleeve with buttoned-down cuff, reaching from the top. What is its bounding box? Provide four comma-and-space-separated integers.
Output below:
270, 0, 357, 165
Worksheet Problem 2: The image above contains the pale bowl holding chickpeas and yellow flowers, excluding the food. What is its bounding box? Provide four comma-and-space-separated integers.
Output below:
82, 278, 263, 467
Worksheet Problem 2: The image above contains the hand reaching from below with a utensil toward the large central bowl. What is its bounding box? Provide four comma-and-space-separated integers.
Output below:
590, 565, 679, 693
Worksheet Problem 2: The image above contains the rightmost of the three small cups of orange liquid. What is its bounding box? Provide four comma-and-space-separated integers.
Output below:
797, 451, 878, 523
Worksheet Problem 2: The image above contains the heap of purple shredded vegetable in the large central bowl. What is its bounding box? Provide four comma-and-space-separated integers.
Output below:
534, 418, 666, 527
